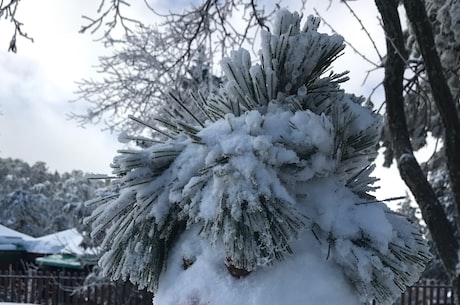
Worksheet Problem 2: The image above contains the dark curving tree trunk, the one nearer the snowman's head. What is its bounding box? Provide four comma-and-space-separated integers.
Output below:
375, 0, 460, 304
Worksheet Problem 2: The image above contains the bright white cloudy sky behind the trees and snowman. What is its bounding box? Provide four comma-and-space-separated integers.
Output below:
0, 0, 412, 199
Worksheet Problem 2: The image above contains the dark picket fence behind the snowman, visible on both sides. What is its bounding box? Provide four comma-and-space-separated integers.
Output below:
0, 270, 453, 305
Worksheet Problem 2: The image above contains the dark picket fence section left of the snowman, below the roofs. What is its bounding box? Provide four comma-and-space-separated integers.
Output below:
0, 270, 153, 305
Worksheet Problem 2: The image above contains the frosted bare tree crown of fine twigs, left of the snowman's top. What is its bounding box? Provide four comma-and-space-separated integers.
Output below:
71, 0, 276, 132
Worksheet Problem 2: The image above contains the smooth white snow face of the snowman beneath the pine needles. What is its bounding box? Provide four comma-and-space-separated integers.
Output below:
154, 230, 359, 305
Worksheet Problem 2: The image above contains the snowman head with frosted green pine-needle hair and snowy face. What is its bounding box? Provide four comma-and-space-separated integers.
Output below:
90, 10, 430, 305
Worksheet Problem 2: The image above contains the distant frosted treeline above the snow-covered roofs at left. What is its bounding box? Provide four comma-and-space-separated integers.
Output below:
0, 158, 105, 236
